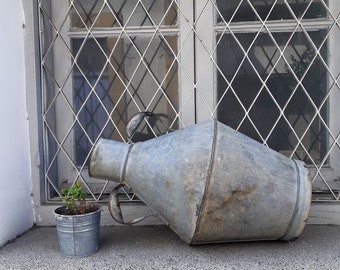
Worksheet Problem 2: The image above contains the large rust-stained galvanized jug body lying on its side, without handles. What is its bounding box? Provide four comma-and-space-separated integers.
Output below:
90, 120, 311, 244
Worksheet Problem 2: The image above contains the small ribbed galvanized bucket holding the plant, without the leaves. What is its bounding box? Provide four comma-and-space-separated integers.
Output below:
54, 206, 102, 257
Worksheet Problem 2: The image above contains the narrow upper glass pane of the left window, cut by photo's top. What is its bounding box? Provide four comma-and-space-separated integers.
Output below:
70, 0, 177, 28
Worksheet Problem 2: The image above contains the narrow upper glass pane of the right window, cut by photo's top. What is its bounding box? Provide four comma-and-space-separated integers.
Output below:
216, 0, 328, 22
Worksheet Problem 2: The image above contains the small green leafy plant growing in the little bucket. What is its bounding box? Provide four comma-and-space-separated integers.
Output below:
60, 179, 86, 215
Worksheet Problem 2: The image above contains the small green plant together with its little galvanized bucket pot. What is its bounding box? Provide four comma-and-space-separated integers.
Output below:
54, 180, 101, 257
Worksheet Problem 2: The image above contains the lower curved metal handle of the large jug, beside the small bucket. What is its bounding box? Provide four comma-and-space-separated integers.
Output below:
108, 183, 156, 225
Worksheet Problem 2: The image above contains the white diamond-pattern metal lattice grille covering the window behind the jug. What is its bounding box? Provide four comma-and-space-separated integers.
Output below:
38, 0, 340, 201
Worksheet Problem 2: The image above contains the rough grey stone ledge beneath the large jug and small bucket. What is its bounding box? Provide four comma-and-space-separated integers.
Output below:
0, 225, 340, 270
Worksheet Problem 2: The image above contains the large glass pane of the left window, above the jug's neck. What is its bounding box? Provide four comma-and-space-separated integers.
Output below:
71, 36, 178, 166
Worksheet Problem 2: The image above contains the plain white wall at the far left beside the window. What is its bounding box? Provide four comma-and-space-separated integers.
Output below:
0, 0, 34, 246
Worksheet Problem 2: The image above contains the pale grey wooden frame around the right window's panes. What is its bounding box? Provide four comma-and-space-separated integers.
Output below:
196, 0, 340, 194
